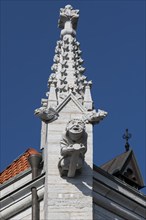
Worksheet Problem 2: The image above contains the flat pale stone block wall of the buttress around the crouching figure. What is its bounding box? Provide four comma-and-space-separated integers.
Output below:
44, 103, 93, 220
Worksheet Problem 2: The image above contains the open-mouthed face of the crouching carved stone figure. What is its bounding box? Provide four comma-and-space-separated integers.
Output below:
66, 119, 85, 140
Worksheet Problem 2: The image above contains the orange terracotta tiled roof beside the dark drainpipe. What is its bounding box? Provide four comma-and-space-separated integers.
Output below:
0, 148, 40, 184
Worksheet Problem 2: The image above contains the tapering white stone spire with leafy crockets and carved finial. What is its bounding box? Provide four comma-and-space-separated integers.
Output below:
48, 5, 89, 104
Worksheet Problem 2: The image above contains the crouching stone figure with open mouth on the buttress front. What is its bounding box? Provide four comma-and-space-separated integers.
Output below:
58, 119, 87, 177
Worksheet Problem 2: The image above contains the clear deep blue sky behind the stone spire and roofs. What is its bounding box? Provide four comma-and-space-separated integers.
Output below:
0, 0, 146, 192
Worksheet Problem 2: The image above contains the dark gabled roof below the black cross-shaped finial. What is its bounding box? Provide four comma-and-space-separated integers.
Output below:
100, 150, 144, 189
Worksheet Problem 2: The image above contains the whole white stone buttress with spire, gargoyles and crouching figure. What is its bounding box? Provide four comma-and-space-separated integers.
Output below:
35, 5, 107, 220
